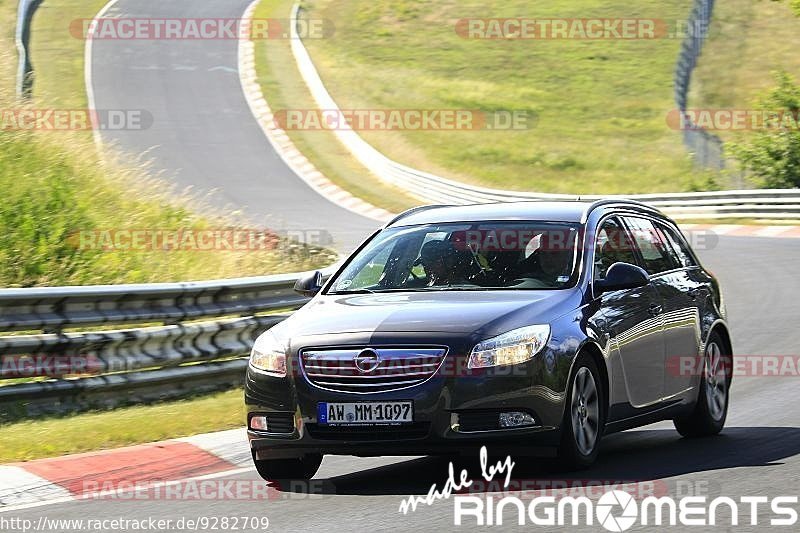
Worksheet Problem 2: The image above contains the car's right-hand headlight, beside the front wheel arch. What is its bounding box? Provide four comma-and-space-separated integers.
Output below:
467, 324, 550, 368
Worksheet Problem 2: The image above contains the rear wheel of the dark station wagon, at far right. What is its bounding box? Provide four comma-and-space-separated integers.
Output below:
673, 332, 731, 438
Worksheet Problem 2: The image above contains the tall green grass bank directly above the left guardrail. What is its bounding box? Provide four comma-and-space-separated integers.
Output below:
0, 123, 336, 287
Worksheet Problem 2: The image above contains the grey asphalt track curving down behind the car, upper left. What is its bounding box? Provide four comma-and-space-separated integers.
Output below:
91, 0, 380, 252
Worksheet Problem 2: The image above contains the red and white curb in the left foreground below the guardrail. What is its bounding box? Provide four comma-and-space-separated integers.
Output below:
0, 428, 252, 513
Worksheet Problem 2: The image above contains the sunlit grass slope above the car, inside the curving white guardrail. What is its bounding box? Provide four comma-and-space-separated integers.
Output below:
304, 0, 699, 193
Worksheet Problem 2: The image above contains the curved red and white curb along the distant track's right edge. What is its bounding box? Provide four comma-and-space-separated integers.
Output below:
234, 0, 394, 222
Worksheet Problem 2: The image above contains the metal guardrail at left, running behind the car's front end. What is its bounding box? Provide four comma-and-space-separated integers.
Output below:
0, 273, 326, 418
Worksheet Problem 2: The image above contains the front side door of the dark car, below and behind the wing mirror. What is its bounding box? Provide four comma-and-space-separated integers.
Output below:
594, 218, 664, 408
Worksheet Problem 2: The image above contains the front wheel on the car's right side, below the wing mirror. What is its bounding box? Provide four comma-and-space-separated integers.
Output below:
558, 353, 605, 470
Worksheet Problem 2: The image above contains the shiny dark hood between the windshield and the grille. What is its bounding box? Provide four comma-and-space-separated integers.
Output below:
282, 290, 579, 336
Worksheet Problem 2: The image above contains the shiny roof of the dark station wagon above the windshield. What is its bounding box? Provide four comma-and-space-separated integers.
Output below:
386, 198, 663, 227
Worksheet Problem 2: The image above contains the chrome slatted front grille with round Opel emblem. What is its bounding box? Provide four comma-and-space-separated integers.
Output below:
300, 347, 447, 393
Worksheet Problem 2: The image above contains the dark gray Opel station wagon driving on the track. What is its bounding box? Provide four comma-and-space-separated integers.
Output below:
245, 200, 732, 479
